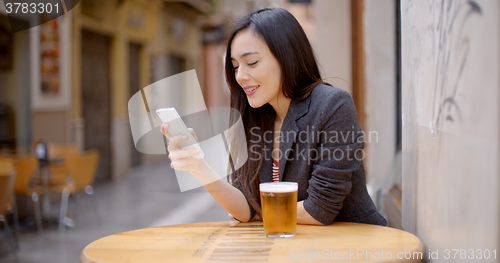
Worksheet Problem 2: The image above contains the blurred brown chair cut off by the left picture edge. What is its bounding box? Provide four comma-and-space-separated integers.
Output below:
0, 158, 17, 261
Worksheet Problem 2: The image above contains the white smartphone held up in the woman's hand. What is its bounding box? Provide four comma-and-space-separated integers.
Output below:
156, 108, 205, 159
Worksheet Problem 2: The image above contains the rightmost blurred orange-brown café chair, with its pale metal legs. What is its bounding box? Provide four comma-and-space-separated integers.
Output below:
50, 150, 100, 232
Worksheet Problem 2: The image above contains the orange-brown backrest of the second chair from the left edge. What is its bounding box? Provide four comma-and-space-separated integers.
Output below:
14, 155, 38, 193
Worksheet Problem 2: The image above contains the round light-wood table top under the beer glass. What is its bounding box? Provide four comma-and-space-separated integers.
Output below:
80, 221, 423, 263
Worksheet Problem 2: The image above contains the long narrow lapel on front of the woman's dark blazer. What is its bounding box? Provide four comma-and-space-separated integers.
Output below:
280, 96, 311, 184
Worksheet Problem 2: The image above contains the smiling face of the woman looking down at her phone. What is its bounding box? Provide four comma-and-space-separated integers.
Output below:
231, 29, 284, 108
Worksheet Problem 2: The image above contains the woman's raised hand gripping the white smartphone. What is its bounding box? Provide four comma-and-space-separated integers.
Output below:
161, 124, 205, 173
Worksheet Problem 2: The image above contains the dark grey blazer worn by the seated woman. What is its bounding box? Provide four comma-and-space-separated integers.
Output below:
250, 84, 387, 226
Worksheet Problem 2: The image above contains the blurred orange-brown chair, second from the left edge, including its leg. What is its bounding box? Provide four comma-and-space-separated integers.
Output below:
13, 155, 44, 233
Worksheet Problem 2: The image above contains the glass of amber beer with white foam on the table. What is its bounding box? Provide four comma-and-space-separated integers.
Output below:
259, 182, 298, 237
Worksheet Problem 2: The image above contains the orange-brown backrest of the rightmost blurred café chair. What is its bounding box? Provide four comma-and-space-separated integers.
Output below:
64, 149, 100, 192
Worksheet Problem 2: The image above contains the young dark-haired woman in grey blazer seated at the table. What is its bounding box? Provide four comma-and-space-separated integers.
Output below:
162, 8, 387, 225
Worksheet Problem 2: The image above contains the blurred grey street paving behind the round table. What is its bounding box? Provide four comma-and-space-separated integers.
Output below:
0, 162, 229, 263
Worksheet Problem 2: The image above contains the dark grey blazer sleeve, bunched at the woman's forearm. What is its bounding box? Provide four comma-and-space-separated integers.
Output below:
304, 90, 364, 225
